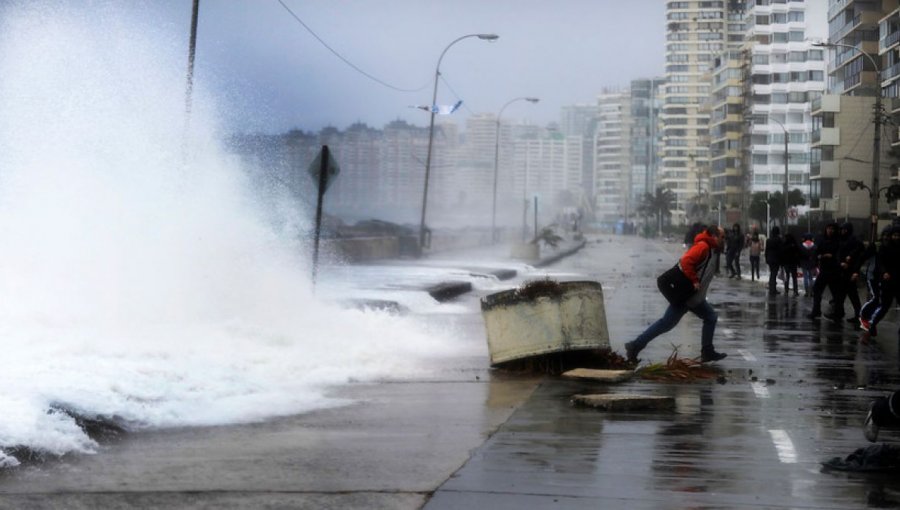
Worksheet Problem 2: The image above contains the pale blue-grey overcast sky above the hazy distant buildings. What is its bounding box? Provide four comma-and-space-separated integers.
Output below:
153, 0, 827, 132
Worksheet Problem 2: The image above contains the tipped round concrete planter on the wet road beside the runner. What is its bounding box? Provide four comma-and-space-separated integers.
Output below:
481, 280, 609, 369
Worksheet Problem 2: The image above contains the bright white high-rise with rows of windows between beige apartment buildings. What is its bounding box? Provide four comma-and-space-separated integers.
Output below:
746, 0, 825, 205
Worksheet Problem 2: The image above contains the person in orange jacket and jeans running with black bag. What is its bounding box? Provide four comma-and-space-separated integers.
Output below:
625, 226, 727, 363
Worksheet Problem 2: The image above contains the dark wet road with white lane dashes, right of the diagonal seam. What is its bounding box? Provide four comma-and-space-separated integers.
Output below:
426, 240, 900, 509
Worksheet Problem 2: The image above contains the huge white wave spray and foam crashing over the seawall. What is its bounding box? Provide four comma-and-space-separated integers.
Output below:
0, 2, 458, 466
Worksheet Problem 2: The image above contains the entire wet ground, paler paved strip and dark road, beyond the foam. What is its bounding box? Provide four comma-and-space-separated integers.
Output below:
0, 236, 900, 509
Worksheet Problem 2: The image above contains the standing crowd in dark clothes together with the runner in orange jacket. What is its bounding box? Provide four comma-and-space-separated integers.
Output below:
625, 223, 900, 362
